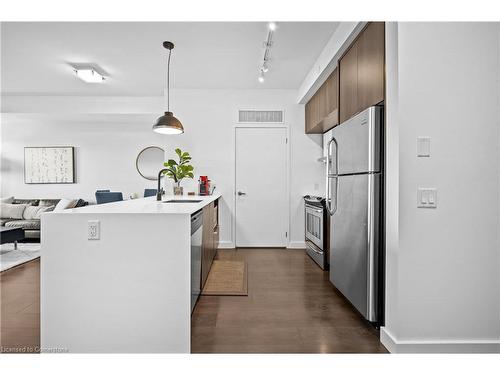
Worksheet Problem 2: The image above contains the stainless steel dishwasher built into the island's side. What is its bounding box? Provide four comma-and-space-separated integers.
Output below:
191, 210, 203, 313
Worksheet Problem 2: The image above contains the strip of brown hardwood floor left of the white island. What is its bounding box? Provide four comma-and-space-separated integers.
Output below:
0, 259, 40, 353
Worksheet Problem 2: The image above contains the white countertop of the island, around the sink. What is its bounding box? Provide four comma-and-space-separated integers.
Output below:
55, 194, 221, 215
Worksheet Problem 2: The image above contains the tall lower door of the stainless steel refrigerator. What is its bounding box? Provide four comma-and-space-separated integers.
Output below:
330, 174, 381, 322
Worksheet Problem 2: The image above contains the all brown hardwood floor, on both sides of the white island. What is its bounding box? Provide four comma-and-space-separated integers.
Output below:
0, 249, 387, 353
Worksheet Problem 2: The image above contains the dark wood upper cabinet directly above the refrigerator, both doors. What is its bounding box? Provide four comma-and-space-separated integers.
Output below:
339, 22, 385, 123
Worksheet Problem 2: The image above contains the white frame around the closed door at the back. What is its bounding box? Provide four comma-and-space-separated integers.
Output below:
231, 123, 290, 248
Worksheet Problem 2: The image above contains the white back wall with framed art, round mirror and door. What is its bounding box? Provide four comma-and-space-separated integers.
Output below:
1, 90, 324, 250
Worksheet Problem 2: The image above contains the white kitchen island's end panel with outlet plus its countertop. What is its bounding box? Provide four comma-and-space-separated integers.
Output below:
40, 194, 220, 353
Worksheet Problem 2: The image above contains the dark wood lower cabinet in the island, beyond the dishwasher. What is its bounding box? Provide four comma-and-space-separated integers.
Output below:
201, 199, 219, 289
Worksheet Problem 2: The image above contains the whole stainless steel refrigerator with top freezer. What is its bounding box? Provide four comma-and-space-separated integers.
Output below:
325, 107, 383, 323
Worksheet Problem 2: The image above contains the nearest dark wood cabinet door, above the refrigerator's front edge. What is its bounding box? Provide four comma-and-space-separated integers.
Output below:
357, 22, 385, 111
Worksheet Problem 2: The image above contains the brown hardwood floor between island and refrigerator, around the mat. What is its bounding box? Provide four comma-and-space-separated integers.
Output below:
191, 249, 387, 353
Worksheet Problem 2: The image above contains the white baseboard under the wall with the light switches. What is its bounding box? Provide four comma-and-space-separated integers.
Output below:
380, 327, 500, 353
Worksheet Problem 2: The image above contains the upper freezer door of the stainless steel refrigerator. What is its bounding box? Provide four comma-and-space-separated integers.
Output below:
329, 107, 382, 175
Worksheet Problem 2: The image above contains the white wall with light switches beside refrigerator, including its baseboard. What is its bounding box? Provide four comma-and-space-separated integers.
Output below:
382, 23, 500, 352
